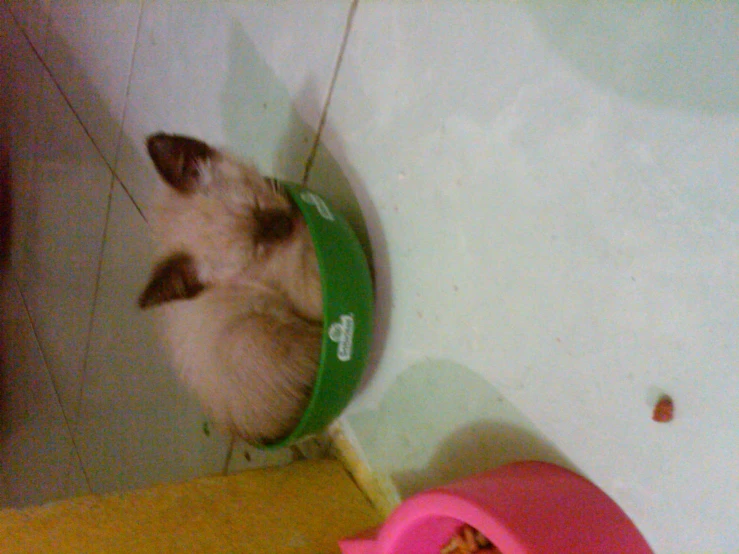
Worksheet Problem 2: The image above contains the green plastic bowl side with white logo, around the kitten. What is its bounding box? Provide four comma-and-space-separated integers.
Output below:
261, 180, 374, 450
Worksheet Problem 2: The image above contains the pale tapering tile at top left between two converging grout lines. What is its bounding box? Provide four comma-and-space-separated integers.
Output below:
44, 0, 146, 166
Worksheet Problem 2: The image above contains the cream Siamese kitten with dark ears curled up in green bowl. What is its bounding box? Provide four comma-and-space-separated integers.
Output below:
139, 133, 323, 444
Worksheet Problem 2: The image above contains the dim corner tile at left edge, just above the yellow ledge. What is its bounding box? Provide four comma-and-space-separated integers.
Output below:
0, 277, 89, 506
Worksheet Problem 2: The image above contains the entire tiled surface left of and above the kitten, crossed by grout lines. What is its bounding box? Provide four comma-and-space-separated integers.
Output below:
0, 0, 349, 505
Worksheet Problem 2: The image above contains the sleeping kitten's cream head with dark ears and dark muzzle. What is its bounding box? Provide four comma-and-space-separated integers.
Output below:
139, 133, 299, 308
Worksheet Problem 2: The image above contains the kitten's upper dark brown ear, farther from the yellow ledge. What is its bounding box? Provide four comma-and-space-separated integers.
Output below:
146, 133, 214, 192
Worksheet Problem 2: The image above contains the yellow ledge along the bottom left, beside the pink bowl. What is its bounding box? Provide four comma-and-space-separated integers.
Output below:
0, 460, 380, 554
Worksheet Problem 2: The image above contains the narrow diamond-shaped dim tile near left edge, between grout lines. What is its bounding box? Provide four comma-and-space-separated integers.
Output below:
14, 67, 112, 417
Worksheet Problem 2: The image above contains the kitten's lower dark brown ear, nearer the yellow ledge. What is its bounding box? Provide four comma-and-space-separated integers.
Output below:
139, 254, 205, 308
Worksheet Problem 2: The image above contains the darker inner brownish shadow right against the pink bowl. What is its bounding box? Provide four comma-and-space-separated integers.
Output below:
393, 420, 577, 498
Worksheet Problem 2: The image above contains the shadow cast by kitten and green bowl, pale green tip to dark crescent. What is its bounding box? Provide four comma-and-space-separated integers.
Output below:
221, 22, 392, 386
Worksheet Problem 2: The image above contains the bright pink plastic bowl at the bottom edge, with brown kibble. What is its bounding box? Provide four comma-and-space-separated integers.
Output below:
339, 462, 652, 554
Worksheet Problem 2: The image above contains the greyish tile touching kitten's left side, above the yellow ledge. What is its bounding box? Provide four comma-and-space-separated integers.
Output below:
74, 185, 228, 492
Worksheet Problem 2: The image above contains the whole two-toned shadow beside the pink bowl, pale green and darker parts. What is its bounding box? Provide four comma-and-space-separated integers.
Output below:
348, 359, 576, 497
